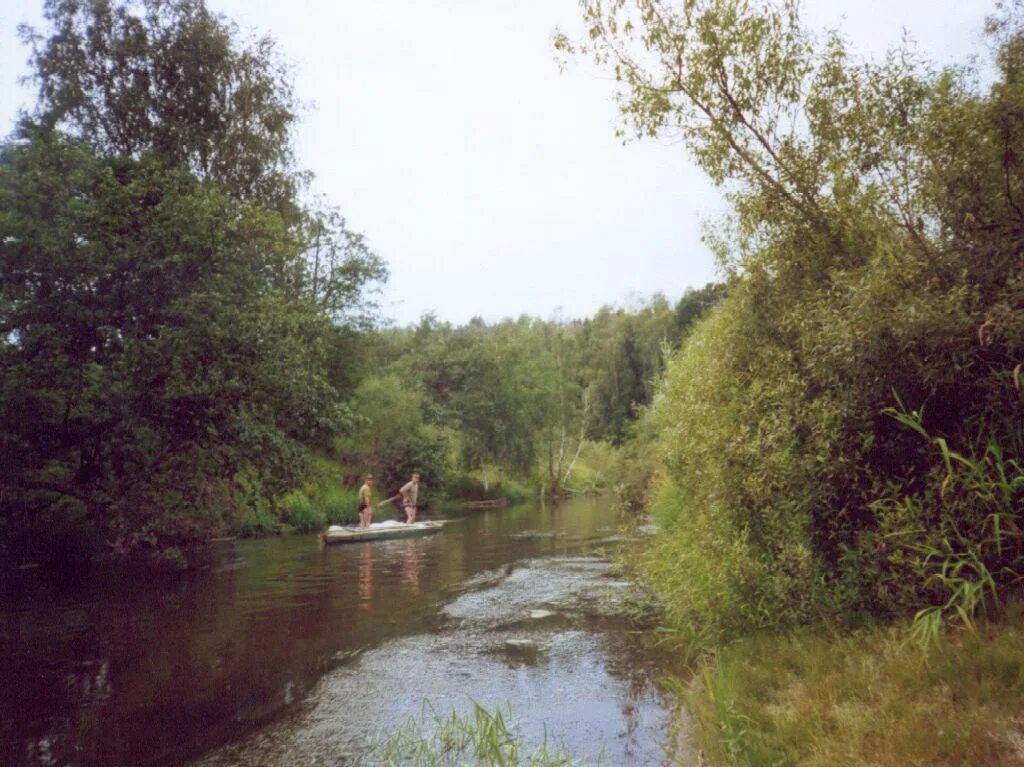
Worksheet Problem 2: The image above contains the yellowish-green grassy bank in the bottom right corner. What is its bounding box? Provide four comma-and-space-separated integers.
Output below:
685, 605, 1024, 767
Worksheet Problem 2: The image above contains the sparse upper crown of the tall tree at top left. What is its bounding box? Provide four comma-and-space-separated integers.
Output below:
20, 0, 304, 214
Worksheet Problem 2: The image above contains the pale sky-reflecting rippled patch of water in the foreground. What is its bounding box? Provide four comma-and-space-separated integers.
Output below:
192, 557, 668, 767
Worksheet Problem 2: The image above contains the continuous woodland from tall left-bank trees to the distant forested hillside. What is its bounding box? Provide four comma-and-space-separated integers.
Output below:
0, 0, 722, 553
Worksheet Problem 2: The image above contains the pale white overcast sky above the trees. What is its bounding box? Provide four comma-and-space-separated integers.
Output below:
0, 0, 993, 325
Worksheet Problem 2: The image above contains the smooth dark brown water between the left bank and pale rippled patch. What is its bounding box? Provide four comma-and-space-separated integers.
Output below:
0, 503, 675, 767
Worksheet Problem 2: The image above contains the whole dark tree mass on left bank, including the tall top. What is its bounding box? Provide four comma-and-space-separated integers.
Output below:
0, 0, 386, 551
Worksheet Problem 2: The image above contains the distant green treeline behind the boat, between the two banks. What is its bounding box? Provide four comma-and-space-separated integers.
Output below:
335, 285, 722, 496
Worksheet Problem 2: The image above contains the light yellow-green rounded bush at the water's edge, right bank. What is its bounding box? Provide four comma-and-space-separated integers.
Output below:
640, 290, 821, 641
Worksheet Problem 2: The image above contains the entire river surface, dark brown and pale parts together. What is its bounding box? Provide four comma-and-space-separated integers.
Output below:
0, 501, 688, 767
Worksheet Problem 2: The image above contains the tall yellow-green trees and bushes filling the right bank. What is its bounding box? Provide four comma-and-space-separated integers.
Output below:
558, 0, 1024, 643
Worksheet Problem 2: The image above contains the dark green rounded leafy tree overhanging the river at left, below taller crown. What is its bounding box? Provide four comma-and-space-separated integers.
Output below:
0, 135, 341, 548
